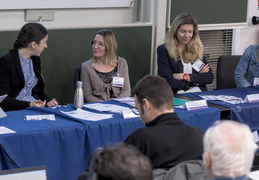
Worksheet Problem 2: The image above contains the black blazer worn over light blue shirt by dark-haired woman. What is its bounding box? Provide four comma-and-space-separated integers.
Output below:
0, 50, 51, 111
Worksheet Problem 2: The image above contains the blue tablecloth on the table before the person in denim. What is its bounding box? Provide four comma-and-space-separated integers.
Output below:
181, 86, 259, 131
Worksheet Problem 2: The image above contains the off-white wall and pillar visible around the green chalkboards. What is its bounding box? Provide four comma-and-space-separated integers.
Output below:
0, 0, 259, 67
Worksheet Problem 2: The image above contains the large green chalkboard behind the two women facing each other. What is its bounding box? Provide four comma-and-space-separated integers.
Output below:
0, 25, 153, 104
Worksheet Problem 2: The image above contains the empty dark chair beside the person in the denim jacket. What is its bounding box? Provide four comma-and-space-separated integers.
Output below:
216, 55, 242, 89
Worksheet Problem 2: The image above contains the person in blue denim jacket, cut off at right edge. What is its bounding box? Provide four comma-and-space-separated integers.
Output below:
235, 44, 259, 87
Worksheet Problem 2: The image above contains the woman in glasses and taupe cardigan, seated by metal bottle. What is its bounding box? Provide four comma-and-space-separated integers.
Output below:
81, 30, 130, 102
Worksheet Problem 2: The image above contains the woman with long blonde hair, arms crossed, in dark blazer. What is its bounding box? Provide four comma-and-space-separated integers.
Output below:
157, 13, 213, 94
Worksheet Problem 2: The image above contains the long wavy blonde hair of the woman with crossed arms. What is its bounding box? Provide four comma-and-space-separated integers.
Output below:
165, 13, 203, 62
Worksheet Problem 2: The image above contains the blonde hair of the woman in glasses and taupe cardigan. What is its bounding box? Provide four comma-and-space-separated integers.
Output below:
92, 29, 118, 67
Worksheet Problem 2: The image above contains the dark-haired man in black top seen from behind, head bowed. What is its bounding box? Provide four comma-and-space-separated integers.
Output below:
125, 75, 204, 169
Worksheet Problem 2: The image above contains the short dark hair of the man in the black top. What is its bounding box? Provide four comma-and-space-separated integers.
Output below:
132, 75, 174, 109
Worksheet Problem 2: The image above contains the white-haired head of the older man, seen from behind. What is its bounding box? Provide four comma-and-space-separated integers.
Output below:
203, 120, 257, 177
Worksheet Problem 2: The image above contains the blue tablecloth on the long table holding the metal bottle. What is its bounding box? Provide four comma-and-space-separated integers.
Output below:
0, 101, 220, 180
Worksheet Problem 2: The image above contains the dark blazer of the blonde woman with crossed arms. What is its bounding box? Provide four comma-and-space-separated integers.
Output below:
157, 44, 213, 94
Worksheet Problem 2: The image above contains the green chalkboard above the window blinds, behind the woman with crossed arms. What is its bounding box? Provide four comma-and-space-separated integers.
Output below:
169, 0, 247, 24
